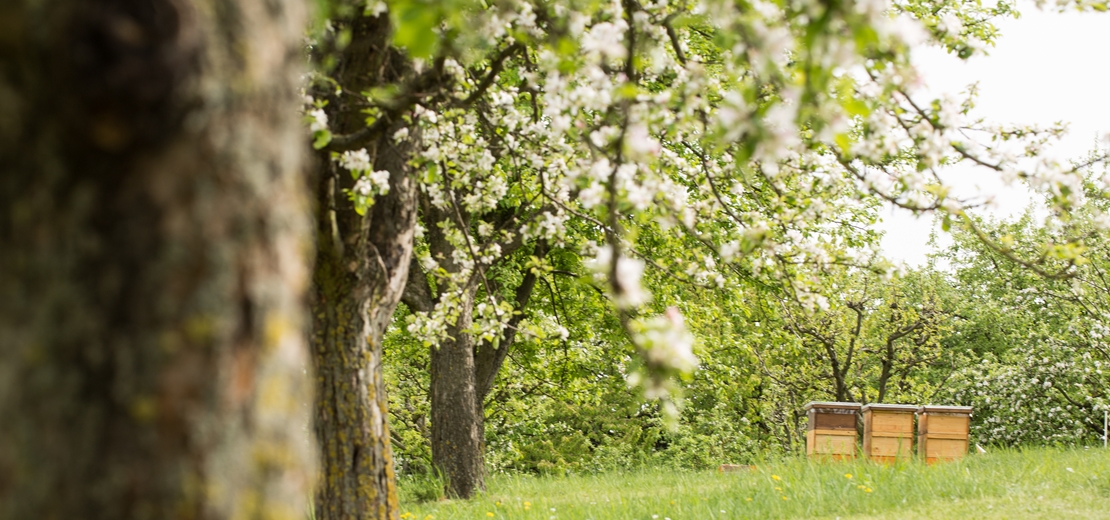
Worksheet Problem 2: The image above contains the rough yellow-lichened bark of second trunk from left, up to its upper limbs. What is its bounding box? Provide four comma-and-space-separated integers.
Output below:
312, 17, 418, 520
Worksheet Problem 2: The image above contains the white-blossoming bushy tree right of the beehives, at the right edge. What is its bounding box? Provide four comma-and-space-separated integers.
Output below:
941, 164, 1110, 444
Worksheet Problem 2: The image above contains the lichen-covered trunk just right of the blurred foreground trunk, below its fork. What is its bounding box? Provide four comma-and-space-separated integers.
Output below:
312, 143, 416, 519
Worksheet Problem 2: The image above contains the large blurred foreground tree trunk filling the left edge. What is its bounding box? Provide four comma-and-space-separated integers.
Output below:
0, 0, 314, 520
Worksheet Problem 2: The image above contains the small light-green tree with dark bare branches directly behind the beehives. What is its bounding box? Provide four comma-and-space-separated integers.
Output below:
768, 265, 960, 403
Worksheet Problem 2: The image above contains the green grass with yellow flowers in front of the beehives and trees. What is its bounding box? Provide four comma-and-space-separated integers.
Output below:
402, 449, 1110, 520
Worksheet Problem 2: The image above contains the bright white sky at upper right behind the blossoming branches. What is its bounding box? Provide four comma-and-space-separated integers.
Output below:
879, 8, 1110, 266
